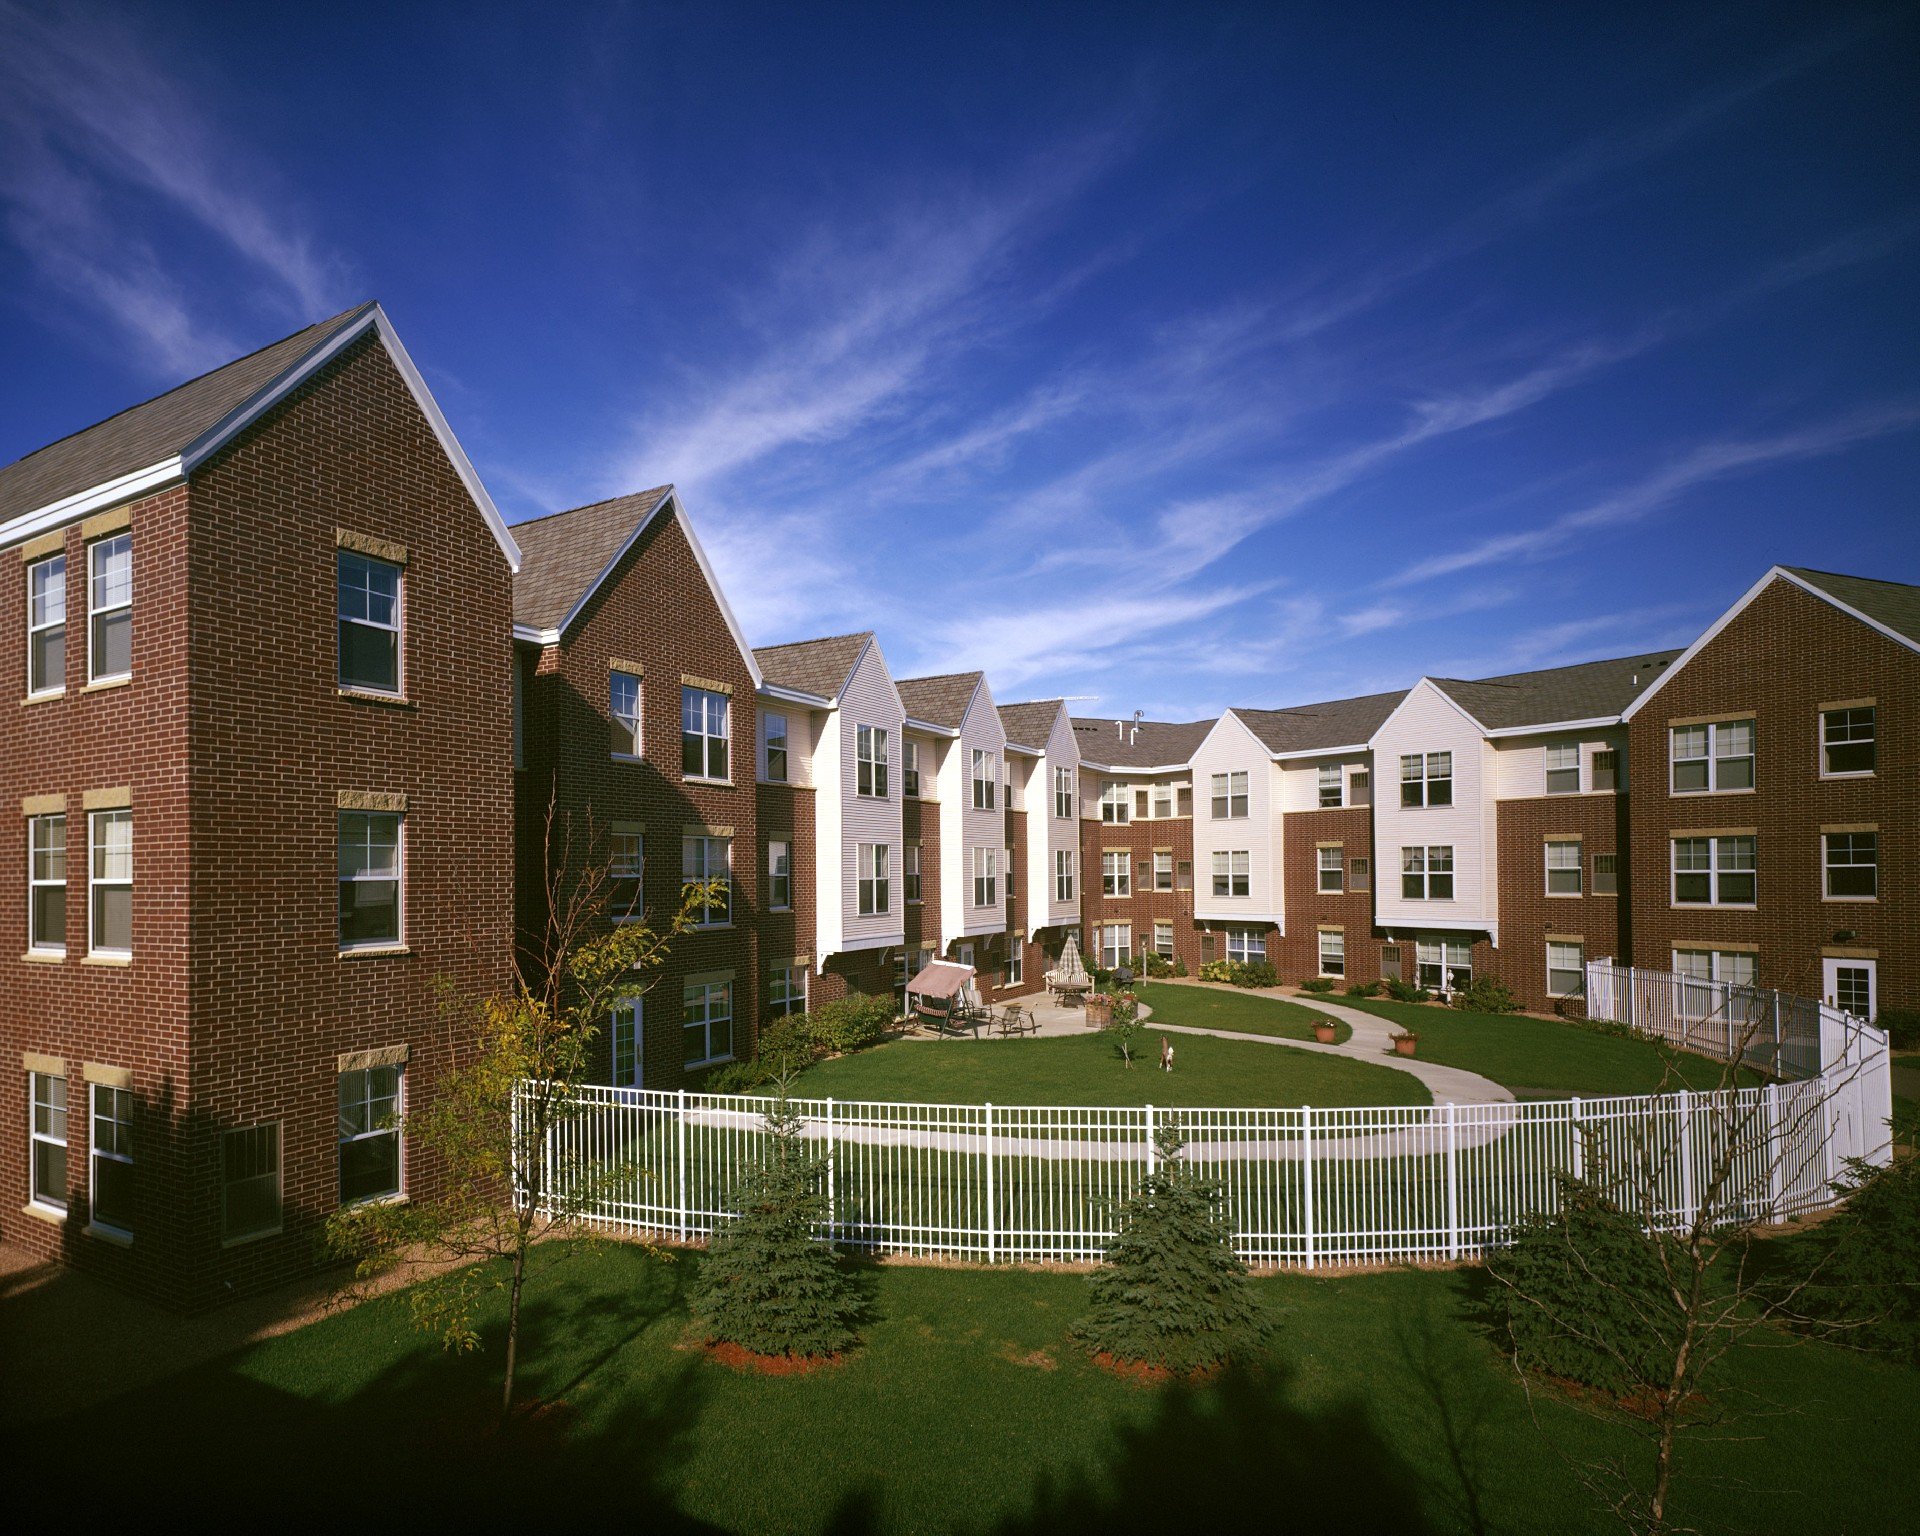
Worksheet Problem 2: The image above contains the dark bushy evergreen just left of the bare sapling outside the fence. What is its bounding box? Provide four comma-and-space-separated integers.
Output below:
1486, 1173, 1684, 1398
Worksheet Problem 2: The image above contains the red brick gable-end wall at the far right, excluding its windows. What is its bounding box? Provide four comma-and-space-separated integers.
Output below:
1628, 580, 1920, 1008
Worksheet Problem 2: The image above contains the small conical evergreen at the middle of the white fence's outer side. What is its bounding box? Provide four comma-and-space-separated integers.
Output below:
1073, 1119, 1269, 1373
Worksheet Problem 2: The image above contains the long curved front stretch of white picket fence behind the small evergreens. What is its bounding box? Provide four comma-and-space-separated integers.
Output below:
528, 979, 1891, 1269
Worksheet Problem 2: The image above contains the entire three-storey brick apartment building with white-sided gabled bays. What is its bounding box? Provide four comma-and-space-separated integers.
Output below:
0, 305, 1920, 1308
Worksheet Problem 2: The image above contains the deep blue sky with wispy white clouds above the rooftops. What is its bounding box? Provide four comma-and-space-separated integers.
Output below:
0, 0, 1920, 718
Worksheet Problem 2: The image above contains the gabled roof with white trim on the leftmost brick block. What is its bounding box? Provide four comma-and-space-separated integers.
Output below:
0, 301, 520, 570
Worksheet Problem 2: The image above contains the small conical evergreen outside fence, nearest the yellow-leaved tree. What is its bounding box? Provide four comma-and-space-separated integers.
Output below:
691, 1091, 862, 1356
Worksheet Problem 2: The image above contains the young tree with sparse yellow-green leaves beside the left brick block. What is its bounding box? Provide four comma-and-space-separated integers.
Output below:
326, 806, 716, 1419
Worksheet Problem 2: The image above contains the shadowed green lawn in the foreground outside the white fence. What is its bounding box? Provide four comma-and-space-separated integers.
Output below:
8, 1244, 1920, 1536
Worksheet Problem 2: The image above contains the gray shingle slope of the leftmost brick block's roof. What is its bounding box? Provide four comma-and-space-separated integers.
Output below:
0, 301, 372, 520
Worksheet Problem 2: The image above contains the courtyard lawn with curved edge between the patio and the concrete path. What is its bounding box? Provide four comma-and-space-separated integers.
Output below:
793, 1021, 1432, 1110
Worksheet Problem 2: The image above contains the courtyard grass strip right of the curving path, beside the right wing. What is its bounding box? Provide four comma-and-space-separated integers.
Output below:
1340, 998, 1757, 1098
